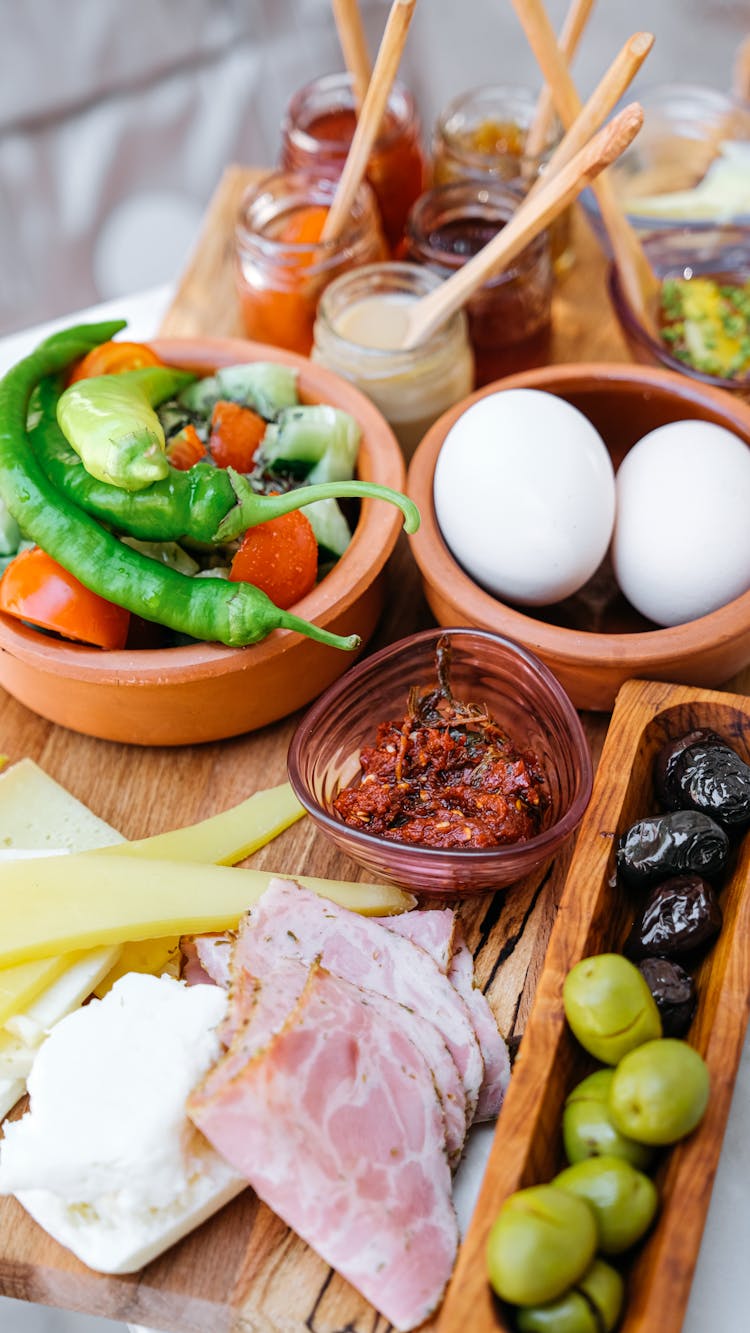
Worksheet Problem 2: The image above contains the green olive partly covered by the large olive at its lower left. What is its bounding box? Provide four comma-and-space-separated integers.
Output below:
553, 1157, 659, 1254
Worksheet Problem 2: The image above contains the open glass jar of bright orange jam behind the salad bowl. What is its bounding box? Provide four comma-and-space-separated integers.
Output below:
234, 172, 386, 356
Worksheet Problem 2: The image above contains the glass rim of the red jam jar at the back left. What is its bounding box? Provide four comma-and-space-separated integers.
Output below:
281, 71, 417, 157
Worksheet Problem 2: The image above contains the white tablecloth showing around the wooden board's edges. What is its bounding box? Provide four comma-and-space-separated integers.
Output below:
0, 294, 750, 1333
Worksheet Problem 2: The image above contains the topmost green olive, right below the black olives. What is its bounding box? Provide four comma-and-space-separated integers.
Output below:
562, 953, 662, 1065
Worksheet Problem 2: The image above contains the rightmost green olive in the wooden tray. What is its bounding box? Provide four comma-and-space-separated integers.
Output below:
609, 1037, 709, 1145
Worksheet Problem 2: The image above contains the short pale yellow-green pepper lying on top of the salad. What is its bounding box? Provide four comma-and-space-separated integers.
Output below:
57, 365, 194, 491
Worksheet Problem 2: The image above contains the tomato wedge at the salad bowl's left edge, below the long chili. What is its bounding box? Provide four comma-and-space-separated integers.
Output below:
0, 547, 131, 649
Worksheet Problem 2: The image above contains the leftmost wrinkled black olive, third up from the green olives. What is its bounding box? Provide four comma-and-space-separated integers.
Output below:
617, 810, 729, 889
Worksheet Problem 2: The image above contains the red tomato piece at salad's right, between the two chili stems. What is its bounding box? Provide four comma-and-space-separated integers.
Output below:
229, 509, 317, 611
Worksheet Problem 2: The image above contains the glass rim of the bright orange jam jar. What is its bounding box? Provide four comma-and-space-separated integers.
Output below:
234, 171, 380, 273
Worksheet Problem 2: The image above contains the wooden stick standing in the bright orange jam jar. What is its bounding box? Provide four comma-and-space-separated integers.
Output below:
321, 0, 417, 241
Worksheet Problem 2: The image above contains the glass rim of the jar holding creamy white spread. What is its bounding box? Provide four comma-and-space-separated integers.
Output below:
316, 261, 469, 375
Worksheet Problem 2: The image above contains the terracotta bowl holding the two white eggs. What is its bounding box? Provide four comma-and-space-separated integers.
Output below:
408, 363, 750, 709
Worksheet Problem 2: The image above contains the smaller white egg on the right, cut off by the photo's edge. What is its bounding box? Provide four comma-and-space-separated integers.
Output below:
613, 421, 750, 625
